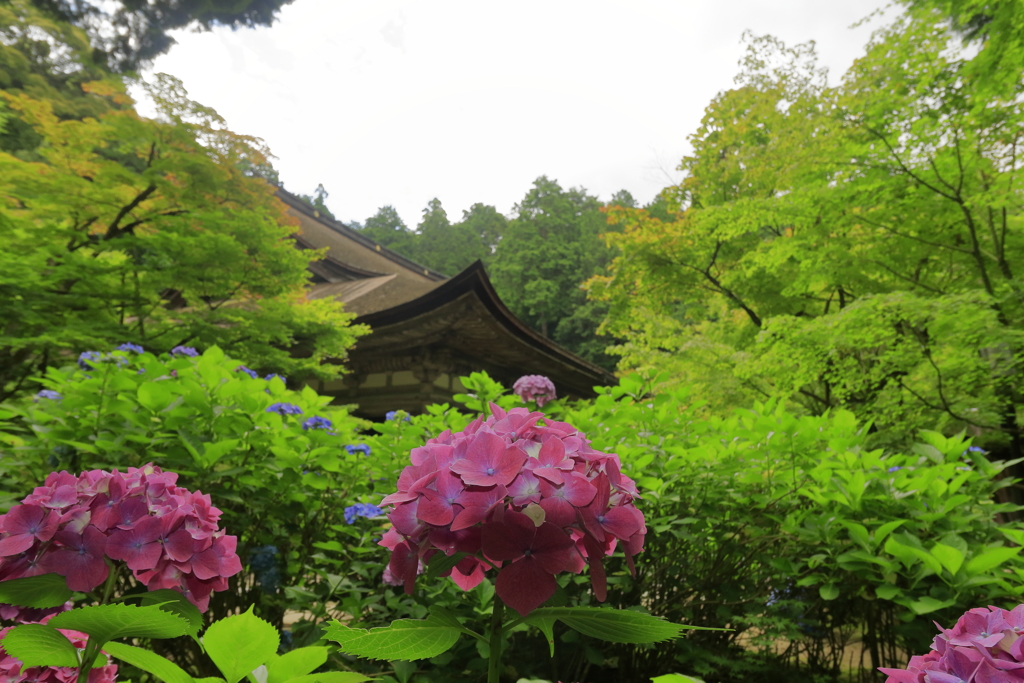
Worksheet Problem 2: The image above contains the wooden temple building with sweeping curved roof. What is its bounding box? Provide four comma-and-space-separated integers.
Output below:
278, 190, 614, 418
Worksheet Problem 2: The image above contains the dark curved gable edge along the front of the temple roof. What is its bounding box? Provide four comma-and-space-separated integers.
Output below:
353, 259, 616, 385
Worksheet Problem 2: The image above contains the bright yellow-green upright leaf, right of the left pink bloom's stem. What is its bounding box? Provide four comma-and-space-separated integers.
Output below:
203, 607, 281, 683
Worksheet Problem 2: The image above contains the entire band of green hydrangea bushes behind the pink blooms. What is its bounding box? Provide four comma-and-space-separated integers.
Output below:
0, 360, 1024, 683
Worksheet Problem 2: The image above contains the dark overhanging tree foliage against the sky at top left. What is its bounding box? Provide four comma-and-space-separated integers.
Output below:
32, 0, 292, 72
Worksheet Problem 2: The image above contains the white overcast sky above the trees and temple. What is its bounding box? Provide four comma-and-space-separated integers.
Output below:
136, 0, 884, 227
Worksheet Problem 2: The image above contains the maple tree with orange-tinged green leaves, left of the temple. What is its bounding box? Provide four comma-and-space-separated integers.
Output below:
0, 62, 366, 396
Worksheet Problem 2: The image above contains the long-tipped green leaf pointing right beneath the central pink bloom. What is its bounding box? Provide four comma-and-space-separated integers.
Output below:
526, 607, 708, 643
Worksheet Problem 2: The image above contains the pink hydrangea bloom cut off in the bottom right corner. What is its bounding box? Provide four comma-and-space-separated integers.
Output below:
880, 605, 1024, 683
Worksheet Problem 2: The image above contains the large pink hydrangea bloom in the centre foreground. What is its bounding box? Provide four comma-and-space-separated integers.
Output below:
380, 403, 647, 614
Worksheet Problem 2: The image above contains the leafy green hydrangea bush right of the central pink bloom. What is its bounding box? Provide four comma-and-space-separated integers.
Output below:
556, 377, 1024, 681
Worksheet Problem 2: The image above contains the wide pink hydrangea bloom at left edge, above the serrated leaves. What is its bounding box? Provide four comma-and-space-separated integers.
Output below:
0, 465, 242, 611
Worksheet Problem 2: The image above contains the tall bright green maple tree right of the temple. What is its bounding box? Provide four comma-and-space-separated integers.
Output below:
590, 12, 1024, 457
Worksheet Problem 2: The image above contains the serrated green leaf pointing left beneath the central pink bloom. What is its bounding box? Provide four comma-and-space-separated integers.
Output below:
324, 612, 462, 660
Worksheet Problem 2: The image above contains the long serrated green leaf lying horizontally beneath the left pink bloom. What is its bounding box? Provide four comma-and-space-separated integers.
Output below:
49, 603, 188, 643
